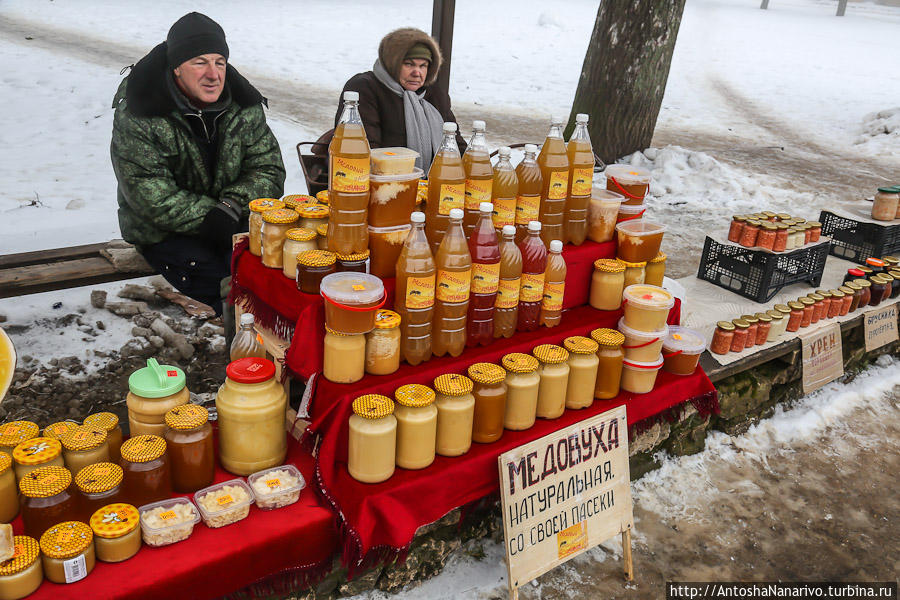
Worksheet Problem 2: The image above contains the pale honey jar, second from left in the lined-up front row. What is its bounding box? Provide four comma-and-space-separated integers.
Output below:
394, 383, 437, 469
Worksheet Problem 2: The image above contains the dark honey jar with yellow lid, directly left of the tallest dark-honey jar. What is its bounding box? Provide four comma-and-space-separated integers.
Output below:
121, 435, 172, 506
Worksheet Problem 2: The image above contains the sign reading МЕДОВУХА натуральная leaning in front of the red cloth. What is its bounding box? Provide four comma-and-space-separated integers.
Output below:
498, 406, 634, 596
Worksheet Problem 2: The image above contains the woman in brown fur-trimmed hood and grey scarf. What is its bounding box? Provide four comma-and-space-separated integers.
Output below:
334, 27, 466, 173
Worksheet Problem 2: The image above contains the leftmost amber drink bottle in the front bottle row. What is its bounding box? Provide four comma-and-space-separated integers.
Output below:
394, 212, 435, 366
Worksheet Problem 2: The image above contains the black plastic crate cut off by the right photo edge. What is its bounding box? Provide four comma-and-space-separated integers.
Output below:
819, 210, 900, 263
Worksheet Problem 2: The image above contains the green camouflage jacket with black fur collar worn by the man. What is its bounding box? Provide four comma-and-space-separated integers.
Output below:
110, 42, 285, 246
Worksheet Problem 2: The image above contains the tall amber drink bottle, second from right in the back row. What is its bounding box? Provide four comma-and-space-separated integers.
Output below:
538, 117, 569, 245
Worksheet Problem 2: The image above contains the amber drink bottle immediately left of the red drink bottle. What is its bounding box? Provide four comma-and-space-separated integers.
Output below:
431, 208, 472, 356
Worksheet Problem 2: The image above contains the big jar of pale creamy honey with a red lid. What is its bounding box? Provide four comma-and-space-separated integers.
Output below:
216, 357, 287, 475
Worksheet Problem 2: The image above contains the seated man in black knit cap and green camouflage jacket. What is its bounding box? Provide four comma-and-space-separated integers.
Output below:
110, 12, 285, 314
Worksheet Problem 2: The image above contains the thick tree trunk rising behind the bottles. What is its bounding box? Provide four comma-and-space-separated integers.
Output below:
566, 0, 685, 162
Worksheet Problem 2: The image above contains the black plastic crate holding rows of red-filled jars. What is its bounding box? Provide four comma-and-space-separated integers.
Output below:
697, 236, 829, 303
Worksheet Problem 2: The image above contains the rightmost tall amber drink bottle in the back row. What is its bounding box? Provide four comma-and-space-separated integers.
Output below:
563, 113, 594, 246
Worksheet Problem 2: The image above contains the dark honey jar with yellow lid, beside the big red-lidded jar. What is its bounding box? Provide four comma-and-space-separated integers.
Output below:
163, 404, 216, 494
